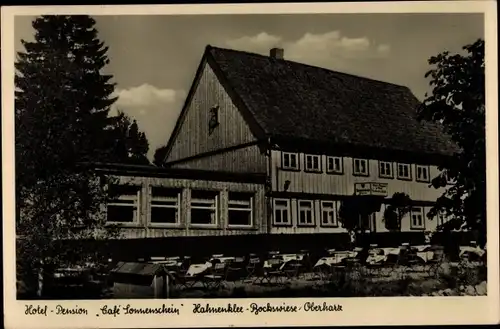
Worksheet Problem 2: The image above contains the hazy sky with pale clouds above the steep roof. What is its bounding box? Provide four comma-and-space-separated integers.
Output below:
14, 13, 484, 159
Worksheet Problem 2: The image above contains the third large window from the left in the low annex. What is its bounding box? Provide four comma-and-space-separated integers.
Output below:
191, 190, 219, 225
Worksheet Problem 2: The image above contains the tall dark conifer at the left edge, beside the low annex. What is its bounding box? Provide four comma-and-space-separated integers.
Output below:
15, 15, 122, 294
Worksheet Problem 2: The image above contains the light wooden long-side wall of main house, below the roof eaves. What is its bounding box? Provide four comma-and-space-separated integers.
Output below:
271, 150, 443, 234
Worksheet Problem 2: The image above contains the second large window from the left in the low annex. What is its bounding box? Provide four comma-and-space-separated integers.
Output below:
150, 187, 181, 224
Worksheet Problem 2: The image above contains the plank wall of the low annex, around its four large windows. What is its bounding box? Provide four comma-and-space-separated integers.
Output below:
107, 174, 267, 239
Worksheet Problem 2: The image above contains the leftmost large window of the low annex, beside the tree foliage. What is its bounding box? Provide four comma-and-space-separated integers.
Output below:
106, 185, 140, 223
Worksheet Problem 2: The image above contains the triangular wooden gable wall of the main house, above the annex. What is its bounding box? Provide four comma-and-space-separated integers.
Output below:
166, 61, 266, 173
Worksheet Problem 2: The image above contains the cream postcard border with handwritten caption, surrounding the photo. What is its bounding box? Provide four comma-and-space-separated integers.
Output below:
1, 1, 500, 328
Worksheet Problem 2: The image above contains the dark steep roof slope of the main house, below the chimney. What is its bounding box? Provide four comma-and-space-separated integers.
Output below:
205, 46, 457, 155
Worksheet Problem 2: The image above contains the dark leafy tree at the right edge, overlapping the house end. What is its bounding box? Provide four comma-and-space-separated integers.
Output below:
419, 39, 486, 245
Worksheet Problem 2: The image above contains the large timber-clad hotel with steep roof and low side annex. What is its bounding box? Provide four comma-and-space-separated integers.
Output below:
98, 46, 456, 256
